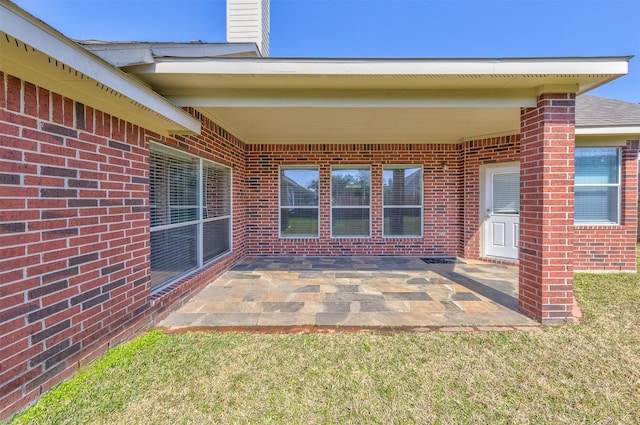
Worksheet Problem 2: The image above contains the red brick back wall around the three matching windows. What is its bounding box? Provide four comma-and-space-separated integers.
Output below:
246, 144, 462, 256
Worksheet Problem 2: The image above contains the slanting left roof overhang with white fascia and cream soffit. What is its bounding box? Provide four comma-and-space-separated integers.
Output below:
0, 0, 200, 134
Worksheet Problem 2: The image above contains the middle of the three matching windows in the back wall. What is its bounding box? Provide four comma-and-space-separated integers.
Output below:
331, 167, 371, 237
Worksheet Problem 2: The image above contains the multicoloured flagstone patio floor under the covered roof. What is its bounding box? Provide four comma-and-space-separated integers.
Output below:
158, 253, 538, 330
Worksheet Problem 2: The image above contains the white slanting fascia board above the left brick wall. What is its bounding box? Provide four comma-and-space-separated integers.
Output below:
0, 1, 200, 133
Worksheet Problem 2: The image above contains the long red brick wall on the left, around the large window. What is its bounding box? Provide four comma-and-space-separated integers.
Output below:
0, 73, 246, 419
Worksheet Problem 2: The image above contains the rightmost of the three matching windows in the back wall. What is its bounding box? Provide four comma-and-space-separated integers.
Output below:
382, 165, 422, 237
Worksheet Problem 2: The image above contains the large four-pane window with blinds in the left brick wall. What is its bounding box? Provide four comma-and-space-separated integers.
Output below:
149, 143, 231, 289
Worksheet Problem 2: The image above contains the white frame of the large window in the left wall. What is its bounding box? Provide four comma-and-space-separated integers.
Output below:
149, 140, 233, 296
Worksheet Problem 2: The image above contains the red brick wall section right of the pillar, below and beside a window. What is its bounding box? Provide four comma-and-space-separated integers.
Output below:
573, 140, 640, 272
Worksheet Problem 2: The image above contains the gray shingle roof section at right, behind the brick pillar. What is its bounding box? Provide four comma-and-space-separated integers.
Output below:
576, 94, 640, 127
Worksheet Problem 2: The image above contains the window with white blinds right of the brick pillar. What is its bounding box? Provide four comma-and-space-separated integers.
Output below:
575, 148, 620, 224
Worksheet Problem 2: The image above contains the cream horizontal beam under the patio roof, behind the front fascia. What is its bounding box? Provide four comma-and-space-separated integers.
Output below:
166, 89, 536, 108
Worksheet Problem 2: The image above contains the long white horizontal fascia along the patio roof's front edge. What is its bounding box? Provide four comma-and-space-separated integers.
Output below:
145, 56, 629, 75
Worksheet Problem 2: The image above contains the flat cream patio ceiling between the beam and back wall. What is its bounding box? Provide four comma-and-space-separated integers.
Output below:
198, 107, 520, 144
